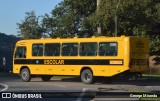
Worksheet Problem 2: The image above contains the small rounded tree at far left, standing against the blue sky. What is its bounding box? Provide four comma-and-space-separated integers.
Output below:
17, 11, 45, 39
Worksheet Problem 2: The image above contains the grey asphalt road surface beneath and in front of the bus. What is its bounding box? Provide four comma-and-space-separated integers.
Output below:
0, 77, 160, 101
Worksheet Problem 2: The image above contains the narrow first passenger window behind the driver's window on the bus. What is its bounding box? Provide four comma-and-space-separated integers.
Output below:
32, 44, 43, 56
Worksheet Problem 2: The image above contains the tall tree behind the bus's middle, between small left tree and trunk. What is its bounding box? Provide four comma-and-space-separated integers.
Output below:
43, 0, 96, 37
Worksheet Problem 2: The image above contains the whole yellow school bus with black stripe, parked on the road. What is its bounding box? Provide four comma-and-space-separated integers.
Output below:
13, 36, 149, 84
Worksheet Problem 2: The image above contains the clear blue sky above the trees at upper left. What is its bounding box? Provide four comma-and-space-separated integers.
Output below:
0, 0, 63, 35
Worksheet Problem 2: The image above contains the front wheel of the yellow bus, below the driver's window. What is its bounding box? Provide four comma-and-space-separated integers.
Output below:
20, 68, 31, 82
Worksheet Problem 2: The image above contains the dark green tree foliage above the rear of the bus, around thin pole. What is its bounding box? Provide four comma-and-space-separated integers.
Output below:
90, 0, 159, 36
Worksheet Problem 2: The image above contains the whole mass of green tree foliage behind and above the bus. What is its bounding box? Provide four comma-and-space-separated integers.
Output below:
17, 0, 160, 52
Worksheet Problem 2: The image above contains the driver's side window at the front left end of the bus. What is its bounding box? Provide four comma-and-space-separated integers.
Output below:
15, 46, 26, 58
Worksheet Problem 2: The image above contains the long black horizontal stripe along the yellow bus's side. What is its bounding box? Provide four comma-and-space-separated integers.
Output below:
14, 59, 123, 65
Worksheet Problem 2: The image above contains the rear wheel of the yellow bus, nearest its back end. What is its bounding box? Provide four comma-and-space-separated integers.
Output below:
81, 69, 94, 84
